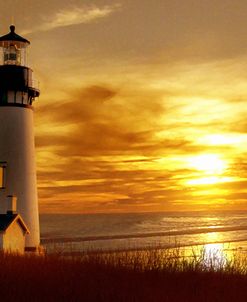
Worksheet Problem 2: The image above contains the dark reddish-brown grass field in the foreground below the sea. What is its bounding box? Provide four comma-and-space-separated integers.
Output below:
0, 248, 247, 302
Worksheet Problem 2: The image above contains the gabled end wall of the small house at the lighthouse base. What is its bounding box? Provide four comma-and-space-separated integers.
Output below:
0, 222, 25, 254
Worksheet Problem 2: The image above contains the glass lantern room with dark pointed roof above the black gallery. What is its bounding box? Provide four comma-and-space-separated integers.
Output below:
0, 25, 30, 66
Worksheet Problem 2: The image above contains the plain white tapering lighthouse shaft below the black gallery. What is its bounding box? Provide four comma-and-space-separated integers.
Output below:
0, 107, 40, 247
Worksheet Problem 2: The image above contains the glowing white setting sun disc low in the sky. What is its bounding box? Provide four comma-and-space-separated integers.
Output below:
188, 154, 227, 176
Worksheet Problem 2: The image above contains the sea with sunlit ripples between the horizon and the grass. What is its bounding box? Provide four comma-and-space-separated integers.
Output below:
40, 211, 247, 252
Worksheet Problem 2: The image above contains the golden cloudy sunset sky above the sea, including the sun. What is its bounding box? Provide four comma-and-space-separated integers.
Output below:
0, 0, 247, 213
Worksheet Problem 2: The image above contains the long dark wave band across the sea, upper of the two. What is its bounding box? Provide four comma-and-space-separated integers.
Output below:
41, 225, 247, 244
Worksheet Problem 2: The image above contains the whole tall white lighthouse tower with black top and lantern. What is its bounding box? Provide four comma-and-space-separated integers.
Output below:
0, 25, 40, 251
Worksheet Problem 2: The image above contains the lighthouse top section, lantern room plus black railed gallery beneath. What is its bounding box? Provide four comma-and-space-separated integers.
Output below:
0, 25, 40, 106
